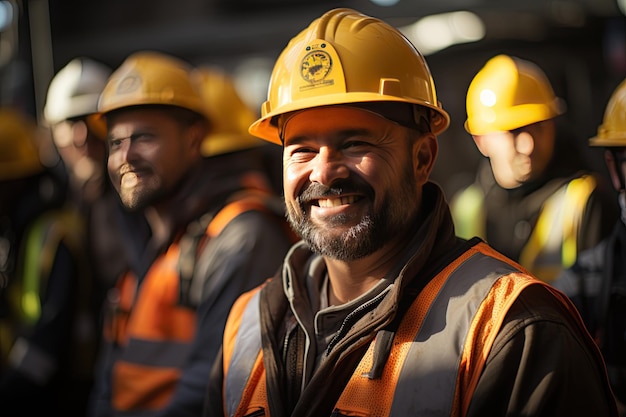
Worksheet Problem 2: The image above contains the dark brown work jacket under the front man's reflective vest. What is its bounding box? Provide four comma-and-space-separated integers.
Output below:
205, 183, 616, 417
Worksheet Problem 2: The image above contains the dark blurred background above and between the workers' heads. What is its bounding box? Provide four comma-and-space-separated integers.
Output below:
0, 0, 626, 195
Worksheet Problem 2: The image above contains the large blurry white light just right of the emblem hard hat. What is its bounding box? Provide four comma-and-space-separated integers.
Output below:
399, 11, 485, 55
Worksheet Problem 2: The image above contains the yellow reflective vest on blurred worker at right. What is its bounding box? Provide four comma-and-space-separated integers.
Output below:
450, 175, 596, 282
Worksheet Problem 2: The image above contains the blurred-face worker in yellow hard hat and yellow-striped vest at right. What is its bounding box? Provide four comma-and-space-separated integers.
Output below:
451, 55, 616, 282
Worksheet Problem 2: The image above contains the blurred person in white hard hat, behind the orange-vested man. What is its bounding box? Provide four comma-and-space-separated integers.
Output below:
44, 57, 147, 311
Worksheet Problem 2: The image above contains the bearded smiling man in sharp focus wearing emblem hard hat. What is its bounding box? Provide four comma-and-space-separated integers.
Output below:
204, 9, 616, 417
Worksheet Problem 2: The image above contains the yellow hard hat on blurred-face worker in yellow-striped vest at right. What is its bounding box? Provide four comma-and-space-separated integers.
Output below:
465, 55, 564, 135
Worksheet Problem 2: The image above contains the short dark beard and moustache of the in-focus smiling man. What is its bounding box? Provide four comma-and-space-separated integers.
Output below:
287, 164, 419, 261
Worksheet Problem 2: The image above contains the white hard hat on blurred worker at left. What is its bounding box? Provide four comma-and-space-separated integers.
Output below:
44, 57, 111, 124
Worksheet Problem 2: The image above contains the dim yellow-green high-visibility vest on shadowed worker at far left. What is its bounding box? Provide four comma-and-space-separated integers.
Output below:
0, 208, 97, 384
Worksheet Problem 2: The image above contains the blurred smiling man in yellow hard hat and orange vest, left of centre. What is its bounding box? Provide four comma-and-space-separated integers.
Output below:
93, 51, 292, 417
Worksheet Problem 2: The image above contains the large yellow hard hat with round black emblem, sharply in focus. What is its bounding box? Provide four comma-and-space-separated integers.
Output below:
250, 8, 450, 144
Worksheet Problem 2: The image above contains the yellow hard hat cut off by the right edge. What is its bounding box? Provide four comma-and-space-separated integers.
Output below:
589, 80, 626, 147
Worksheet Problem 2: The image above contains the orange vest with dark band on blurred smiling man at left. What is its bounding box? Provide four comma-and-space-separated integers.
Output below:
104, 195, 292, 412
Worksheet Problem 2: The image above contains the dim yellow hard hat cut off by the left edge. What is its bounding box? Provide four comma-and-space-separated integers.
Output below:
0, 108, 43, 181
